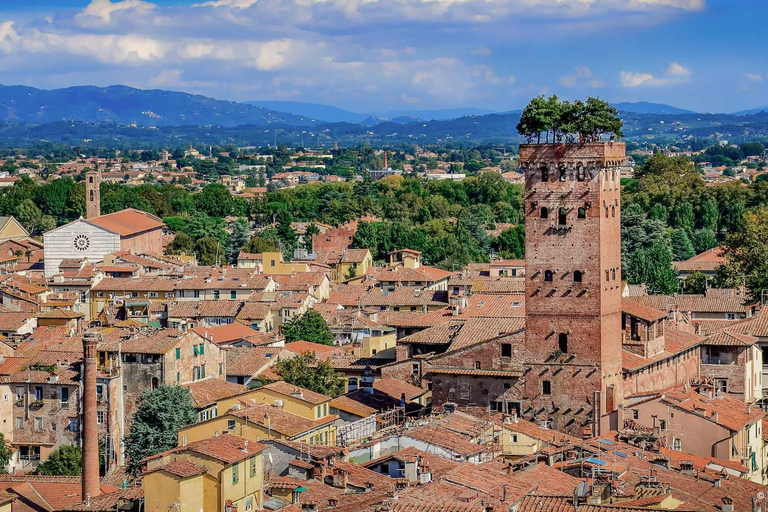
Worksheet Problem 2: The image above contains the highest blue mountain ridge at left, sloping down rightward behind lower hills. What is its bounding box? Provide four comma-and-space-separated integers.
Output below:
0, 85, 314, 126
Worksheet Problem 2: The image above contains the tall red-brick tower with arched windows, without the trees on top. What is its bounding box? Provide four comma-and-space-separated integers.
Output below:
519, 142, 625, 435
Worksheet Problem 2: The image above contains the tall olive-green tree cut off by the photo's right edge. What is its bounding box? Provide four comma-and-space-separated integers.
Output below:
723, 207, 768, 304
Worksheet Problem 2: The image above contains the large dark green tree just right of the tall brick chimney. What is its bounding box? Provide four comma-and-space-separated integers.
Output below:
125, 386, 197, 475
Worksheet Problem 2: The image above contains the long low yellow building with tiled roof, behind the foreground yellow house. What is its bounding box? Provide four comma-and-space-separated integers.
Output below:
178, 399, 338, 446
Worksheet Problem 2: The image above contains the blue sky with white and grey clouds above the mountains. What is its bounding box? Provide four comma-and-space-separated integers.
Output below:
0, 0, 768, 112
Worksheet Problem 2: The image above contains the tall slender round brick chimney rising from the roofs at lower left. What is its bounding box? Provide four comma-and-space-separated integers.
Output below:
81, 333, 101, 502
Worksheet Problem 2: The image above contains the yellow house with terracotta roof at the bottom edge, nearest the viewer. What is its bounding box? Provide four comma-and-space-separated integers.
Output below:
141, 435, 265, 512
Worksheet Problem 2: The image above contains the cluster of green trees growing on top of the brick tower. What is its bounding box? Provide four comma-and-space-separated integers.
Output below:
517, 96, 624, 144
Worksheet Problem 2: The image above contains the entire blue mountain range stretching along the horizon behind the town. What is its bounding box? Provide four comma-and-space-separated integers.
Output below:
0, 85, 768, 147
